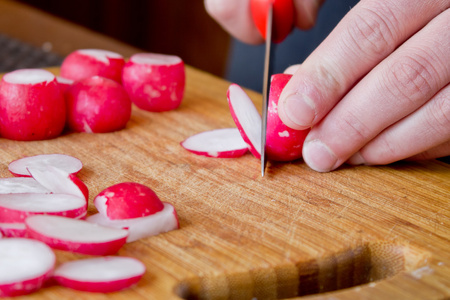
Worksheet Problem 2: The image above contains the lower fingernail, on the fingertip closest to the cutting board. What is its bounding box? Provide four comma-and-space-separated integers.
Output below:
303, 140, 338, 172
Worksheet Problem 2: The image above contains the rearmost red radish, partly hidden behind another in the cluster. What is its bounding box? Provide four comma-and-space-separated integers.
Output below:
60, 49, 125, 83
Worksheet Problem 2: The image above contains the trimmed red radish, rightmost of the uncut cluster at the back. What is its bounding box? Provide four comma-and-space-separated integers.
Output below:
122, 53, 185, 112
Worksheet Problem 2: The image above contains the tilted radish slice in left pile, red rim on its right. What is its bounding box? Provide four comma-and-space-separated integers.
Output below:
28, 166, 89, 204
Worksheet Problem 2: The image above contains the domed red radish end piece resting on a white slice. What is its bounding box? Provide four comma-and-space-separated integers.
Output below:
94, 182, 164, 220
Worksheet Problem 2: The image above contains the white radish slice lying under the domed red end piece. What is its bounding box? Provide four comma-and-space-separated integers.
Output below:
86, 203, 180, 243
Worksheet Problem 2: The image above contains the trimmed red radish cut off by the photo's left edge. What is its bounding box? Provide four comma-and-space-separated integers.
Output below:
0, 69, 66, 141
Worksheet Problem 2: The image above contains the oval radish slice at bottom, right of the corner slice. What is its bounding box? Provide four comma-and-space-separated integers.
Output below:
53, 256, 145, 293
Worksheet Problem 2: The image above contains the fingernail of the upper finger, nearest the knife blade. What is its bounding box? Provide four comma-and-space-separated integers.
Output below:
284, 95, 316, 128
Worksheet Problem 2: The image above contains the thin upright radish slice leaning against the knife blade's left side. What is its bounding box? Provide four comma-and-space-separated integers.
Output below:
227, 83, 262, 159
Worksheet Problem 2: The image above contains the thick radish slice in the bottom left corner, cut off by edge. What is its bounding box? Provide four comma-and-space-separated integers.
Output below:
0, 238, 56, 297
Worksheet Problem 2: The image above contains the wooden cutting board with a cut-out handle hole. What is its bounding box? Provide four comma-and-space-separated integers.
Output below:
0, 67, 450, 300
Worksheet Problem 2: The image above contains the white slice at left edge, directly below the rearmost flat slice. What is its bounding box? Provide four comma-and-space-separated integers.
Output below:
0, 177, 50, 194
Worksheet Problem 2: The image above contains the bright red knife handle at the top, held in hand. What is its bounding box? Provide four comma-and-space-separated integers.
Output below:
250, 0, 295, 43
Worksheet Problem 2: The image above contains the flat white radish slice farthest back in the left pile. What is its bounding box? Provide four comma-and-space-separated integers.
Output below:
8, 154, 83, 177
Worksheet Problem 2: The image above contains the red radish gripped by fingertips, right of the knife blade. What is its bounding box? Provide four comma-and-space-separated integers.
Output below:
266, 74, 310, 161
